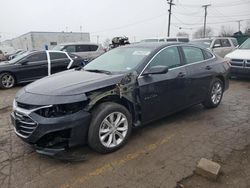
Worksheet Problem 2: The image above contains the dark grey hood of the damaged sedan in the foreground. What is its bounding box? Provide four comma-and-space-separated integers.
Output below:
25, 70, 124, 96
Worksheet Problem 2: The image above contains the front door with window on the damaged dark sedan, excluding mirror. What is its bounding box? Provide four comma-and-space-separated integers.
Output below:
138, 47, 188, 123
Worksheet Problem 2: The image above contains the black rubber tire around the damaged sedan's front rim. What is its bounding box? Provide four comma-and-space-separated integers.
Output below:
88, 102, 132, 153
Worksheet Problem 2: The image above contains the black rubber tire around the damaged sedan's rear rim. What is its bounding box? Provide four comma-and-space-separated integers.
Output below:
202, 78, 224, 108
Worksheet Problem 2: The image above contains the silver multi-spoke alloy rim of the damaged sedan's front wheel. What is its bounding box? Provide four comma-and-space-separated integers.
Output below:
99, 112, 128, 148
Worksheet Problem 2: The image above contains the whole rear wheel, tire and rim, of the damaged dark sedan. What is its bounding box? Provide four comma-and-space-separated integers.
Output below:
202, 78, 224, 108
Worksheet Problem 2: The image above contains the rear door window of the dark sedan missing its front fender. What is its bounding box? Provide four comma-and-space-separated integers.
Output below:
182, 46, 204, 64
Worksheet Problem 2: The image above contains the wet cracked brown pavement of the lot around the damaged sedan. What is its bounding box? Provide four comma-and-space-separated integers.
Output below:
0, 80, 250, 188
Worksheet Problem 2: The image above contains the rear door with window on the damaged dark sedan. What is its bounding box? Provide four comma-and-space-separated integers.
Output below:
182, 46, 213, 105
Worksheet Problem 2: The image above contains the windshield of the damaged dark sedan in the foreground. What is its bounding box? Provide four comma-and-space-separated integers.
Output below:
84, 48, 152, 73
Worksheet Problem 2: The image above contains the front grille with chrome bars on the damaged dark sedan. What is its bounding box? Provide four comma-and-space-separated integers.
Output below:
14, 112, 37, 137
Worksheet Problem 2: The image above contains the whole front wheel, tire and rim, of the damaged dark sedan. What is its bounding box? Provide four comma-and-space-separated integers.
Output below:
88, 102, 132, 153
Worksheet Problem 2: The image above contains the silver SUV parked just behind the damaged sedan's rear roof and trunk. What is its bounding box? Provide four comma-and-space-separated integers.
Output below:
191, 37, 238, 57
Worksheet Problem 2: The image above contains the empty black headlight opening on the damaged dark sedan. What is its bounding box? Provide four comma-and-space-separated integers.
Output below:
36, 102, 85, 118
